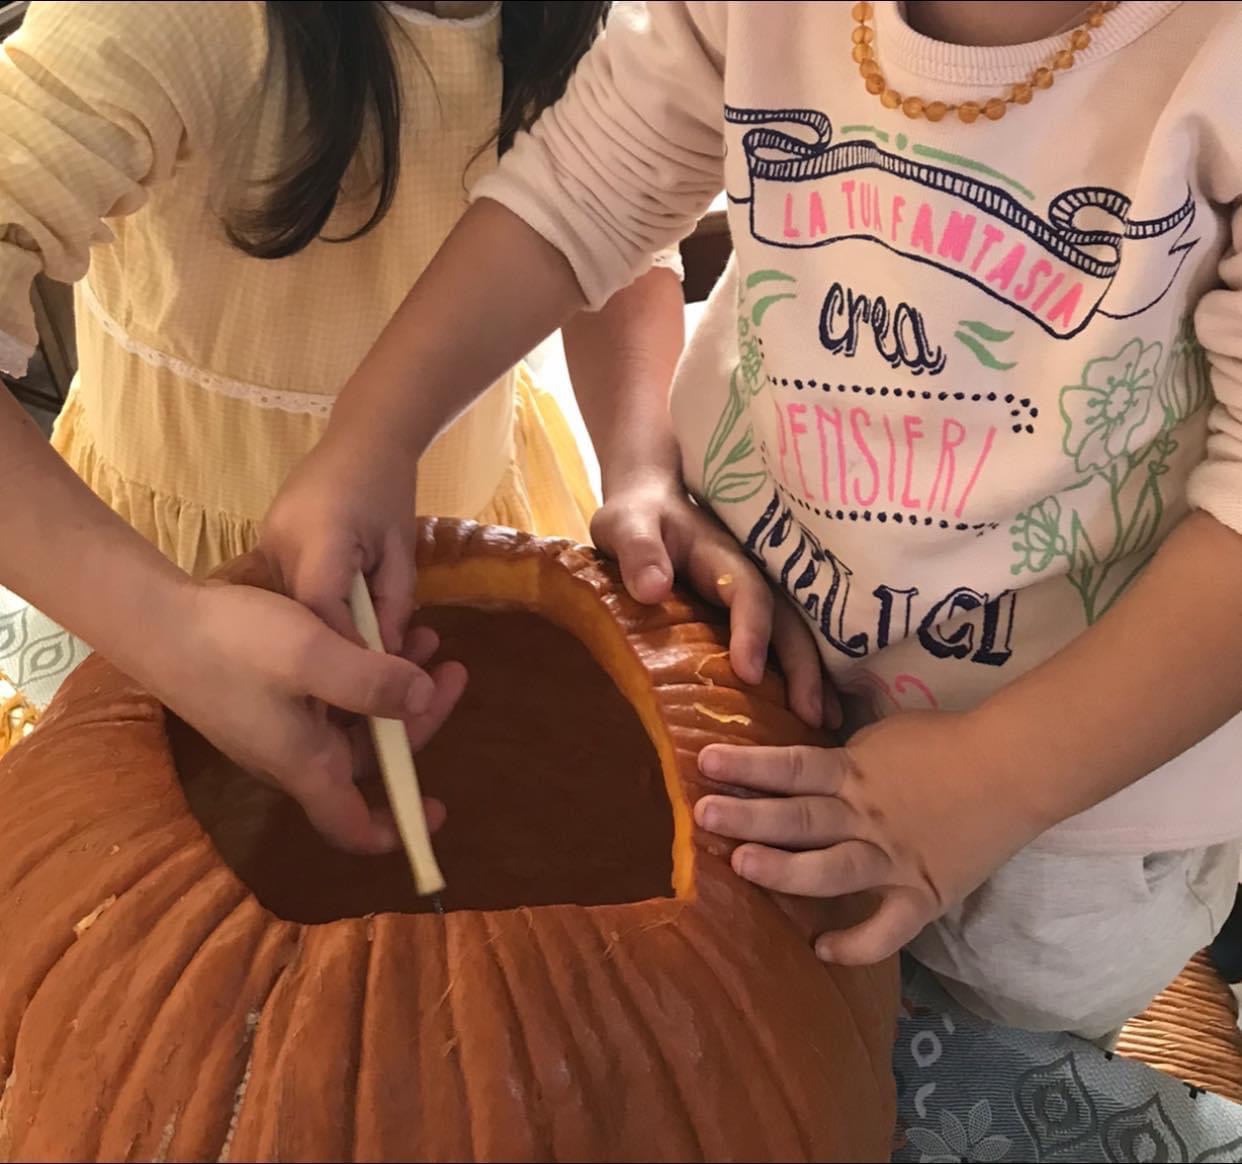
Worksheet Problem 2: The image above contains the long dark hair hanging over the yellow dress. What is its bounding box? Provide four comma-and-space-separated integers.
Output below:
225, 0, 609, 258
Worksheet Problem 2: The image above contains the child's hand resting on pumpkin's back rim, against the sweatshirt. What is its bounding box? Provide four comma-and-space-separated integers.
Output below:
591, 471, 841, 727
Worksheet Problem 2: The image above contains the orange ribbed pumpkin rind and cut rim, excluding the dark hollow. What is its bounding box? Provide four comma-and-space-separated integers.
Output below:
0, 521, 897, 1160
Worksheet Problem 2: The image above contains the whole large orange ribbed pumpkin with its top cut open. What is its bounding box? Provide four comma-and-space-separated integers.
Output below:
0, 521, 897, 1160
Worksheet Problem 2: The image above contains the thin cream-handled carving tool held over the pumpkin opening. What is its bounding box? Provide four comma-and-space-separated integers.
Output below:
349, 573, 445, 913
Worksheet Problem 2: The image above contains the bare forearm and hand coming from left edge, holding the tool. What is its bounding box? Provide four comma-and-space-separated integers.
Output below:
0, 391, 465, 852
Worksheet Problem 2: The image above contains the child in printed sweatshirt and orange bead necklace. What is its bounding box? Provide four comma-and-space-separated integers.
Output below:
268, 0, 1242, 1041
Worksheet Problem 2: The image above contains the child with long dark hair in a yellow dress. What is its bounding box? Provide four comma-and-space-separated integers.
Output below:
0, 2, 720, 847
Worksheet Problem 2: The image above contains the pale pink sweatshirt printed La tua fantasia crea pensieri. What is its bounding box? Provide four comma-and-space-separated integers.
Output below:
474, 0, 1242, 852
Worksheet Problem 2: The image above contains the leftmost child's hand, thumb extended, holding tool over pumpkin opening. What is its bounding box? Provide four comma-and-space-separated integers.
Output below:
152, 584, 466, 852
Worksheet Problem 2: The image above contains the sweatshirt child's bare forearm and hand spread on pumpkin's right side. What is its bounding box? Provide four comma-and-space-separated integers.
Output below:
696, 512, 1242, 963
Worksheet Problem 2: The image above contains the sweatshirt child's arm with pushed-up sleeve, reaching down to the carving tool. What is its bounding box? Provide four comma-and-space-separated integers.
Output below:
265, 2, 728, 640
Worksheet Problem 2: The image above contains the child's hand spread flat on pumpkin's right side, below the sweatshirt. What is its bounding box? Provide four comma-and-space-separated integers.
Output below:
694, 712, 1051, 964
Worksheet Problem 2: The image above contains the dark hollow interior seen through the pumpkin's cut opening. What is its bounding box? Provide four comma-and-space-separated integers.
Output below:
169, 606, 673, 923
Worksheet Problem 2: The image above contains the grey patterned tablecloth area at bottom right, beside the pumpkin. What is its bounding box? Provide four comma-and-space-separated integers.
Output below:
893, 962, 1242, 1164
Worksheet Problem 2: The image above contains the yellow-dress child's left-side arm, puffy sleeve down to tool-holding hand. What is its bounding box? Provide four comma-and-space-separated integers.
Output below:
0, 2, 461, 850
